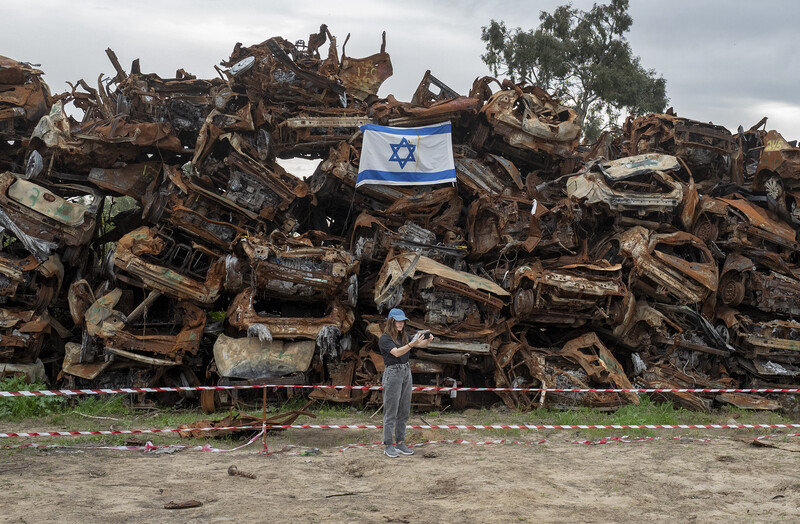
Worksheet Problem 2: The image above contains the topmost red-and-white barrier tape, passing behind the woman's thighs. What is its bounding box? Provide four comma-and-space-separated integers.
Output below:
0, 384, 800, 397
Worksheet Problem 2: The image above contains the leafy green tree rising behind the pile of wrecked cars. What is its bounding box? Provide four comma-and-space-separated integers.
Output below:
481, 0, 668, 139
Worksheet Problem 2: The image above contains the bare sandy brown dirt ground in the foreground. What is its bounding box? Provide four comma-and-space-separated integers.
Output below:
0, 424, 800, 523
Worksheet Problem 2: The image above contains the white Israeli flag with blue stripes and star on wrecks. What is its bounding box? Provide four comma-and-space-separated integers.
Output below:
356, 122, 456, 187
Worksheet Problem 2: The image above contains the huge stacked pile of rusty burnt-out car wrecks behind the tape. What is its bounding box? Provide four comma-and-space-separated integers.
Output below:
0, 26, 800, 410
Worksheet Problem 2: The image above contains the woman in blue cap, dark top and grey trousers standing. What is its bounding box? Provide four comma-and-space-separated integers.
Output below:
378, 308, 433, 458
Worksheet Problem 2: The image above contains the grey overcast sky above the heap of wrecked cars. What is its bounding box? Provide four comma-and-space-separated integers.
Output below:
0, 0, 800, 149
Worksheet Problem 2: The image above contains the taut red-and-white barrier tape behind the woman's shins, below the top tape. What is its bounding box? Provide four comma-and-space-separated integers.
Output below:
0, 424, 800, 438
